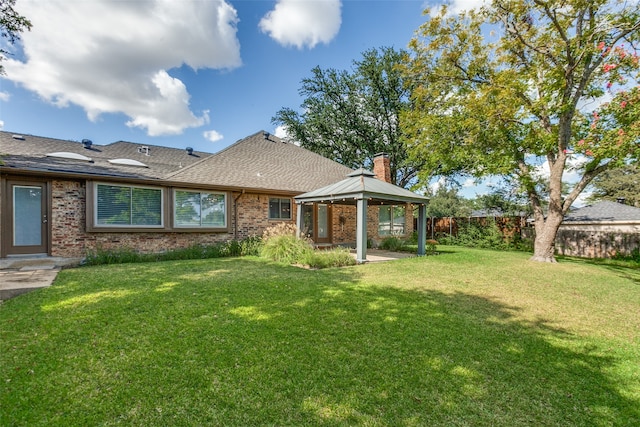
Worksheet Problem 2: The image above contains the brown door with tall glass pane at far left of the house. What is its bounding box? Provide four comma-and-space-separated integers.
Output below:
3, 181, 49, 255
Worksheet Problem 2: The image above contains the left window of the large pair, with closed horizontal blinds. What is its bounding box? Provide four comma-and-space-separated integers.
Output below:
95, 184, 162, 227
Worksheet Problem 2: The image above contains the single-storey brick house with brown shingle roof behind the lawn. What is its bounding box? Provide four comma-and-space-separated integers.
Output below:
0, 132, 424, 258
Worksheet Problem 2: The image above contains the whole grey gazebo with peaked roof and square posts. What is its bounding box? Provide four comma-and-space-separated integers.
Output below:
294, 168, 429, 263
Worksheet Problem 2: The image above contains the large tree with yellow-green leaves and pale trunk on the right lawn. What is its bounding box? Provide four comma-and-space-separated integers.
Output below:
402, 0, 640, 262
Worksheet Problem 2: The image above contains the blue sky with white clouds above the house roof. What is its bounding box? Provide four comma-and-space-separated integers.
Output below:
0, 0, 468, 152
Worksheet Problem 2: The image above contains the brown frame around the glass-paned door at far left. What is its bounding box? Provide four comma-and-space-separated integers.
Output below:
0, 177, 51, 258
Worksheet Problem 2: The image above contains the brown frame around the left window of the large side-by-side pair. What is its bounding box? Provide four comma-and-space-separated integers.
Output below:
87, 181, 166, 232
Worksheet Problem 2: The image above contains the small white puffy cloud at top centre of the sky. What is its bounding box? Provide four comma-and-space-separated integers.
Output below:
259, 0, 342, 49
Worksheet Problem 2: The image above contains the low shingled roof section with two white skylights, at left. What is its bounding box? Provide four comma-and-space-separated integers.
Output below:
0, 132, 211, 179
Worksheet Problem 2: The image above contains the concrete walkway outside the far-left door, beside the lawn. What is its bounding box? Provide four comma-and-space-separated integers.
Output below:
0, 256, 80, 301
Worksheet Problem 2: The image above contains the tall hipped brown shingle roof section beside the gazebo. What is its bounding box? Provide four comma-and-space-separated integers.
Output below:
167, 131, 352, 193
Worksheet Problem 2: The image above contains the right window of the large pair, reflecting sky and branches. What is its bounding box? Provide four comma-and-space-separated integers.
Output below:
173, 190, 227, 228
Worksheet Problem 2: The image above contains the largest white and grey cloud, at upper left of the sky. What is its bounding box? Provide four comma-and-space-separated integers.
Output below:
5, 0, 241, 136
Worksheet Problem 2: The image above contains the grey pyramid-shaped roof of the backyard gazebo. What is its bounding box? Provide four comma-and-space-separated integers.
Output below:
295, 168, 429, 205
